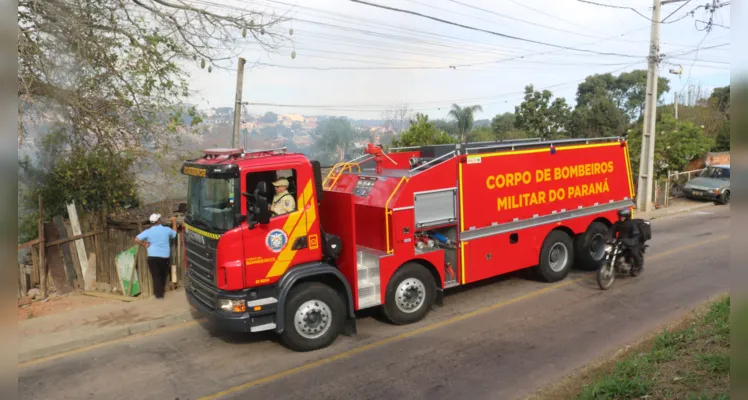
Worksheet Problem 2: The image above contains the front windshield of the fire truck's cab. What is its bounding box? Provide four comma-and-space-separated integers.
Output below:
187, 176, 239, 231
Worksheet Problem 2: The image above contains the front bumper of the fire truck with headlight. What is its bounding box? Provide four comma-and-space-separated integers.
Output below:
185, 277, 278, 333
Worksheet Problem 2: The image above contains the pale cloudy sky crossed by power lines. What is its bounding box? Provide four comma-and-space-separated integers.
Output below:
187, 0, 731, 119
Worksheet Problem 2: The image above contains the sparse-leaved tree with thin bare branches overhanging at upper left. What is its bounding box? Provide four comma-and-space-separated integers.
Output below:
18, 0, 285, 151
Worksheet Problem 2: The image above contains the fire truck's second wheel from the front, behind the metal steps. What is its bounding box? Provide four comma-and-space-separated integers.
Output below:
383, 263, 436, 325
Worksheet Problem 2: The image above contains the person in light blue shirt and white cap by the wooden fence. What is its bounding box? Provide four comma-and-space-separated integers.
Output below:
135, 214, 177, 299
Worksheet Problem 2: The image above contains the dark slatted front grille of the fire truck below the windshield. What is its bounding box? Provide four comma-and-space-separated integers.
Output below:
185, 233, 218, 308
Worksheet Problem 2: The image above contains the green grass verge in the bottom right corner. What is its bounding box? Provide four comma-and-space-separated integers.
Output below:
534, 296, 730, 400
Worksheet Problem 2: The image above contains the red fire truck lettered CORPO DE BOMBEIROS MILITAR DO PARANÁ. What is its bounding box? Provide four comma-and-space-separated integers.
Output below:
182, 138, 634, 351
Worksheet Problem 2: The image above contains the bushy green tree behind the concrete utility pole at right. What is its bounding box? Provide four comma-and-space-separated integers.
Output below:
629, 113, 714, 178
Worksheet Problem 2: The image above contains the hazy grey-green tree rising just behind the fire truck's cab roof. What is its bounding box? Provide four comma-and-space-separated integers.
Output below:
313, 117, 356, 165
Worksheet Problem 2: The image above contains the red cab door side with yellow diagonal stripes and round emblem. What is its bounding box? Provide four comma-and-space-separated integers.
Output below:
243, 165, 321, 286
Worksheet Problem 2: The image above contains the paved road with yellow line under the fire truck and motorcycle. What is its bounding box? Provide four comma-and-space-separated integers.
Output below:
19, 207, 730, 400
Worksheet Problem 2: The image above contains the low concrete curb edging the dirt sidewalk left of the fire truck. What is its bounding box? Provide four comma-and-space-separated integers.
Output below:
18, 310, 195, 364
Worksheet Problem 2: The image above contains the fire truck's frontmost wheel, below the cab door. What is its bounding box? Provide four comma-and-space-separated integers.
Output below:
281, 282, 346, 352
